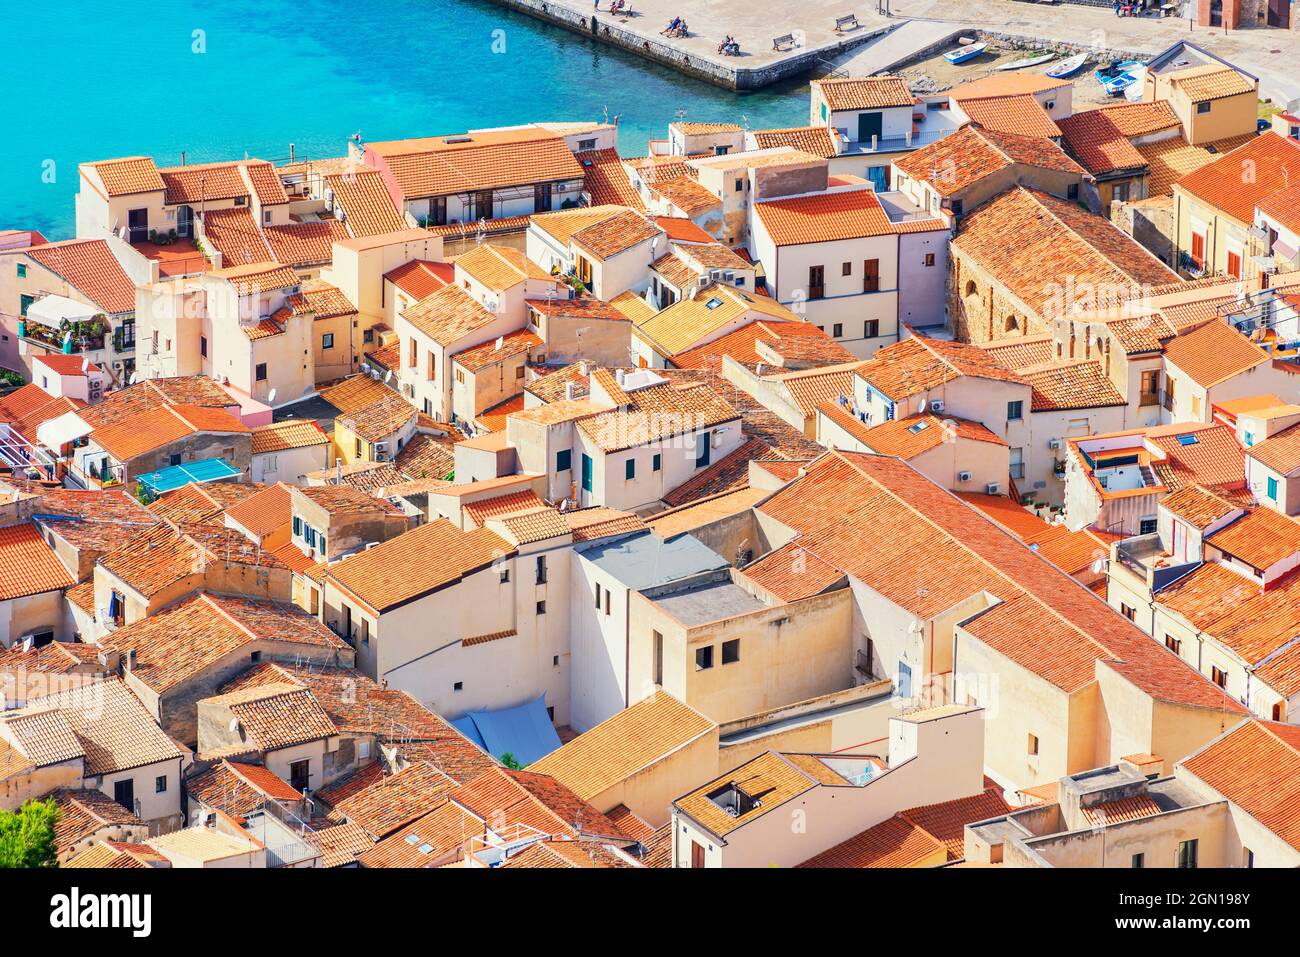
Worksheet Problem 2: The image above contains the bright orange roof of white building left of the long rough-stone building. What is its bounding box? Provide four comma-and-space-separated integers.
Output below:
754, 190, 946, 246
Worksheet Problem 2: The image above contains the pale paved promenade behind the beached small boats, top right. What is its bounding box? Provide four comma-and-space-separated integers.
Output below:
891, 0, 1300, 103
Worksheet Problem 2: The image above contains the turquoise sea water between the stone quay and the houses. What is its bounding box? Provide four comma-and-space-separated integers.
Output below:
0, 0, 807, 239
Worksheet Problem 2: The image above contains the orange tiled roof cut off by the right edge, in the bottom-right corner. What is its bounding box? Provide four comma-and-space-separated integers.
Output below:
1180, 719, 1300, 850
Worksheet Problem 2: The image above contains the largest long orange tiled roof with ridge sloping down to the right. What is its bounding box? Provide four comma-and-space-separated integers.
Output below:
758, 451, 1239, 710
